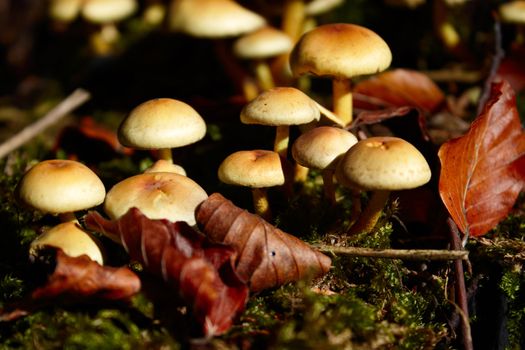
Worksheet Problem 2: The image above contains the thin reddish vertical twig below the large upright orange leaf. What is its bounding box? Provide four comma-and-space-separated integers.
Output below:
447, 218, 474, 350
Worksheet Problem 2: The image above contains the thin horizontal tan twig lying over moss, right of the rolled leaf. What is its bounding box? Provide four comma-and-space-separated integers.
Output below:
314, 245, 468, 260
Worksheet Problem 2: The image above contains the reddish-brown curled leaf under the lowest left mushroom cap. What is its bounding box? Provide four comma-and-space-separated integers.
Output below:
32, 249, 140, 300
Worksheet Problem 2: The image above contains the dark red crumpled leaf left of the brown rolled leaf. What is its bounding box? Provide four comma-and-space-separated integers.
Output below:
85, 208, 248, 336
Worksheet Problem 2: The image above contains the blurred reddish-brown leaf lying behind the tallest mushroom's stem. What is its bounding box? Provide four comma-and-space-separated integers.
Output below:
354, 68, 445, 113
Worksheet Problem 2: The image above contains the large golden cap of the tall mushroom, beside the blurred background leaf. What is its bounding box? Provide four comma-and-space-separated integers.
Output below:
290, 23, 392, 78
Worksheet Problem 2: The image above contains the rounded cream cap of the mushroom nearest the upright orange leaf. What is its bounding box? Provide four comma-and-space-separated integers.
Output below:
336, 137, 431, 191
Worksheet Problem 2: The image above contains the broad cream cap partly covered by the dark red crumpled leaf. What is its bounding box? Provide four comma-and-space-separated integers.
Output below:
104, 172, 208, 226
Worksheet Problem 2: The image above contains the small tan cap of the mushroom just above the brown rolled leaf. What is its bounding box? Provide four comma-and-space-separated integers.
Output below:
218, 150, 285, 188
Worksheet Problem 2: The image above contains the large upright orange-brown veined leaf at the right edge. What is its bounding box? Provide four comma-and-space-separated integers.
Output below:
439, 82, 525, 236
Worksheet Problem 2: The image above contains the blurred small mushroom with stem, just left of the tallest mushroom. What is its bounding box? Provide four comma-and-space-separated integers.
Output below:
233, 26, 293, 90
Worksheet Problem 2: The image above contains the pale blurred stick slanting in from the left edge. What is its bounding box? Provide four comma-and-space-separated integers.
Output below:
0, 89, 90, 159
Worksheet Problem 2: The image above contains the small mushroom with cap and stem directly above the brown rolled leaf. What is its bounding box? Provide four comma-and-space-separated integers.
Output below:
218, 150, 287, 220
